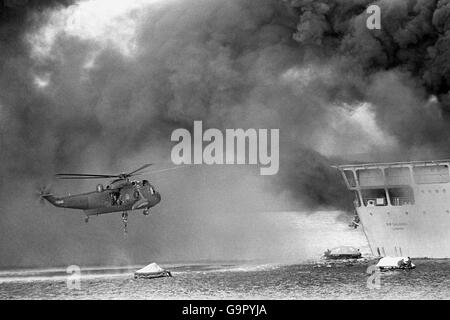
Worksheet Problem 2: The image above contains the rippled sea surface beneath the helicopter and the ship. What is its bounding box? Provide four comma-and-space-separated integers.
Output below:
0, 260, 450, 299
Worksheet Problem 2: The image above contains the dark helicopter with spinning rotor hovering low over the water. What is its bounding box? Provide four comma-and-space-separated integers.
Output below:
38, 163, 162, 234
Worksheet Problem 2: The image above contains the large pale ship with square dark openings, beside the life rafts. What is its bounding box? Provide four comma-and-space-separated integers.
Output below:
335, 160, 450, 259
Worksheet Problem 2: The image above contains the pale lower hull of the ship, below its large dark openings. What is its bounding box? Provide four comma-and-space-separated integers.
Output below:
356, 186, 450, 258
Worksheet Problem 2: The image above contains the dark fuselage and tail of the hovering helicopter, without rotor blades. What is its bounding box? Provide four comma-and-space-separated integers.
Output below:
43, 179, 161, 216
